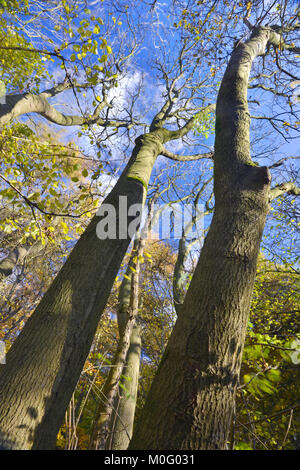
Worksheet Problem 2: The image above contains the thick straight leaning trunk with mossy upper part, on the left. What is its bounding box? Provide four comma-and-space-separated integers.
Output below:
0, 129, 165, 449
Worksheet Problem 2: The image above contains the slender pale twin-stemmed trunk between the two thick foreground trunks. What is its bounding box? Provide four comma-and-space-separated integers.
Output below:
90, 197, 157, 449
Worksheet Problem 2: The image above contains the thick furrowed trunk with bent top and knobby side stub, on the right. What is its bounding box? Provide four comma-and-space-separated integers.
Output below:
129, 28, 278, 450
